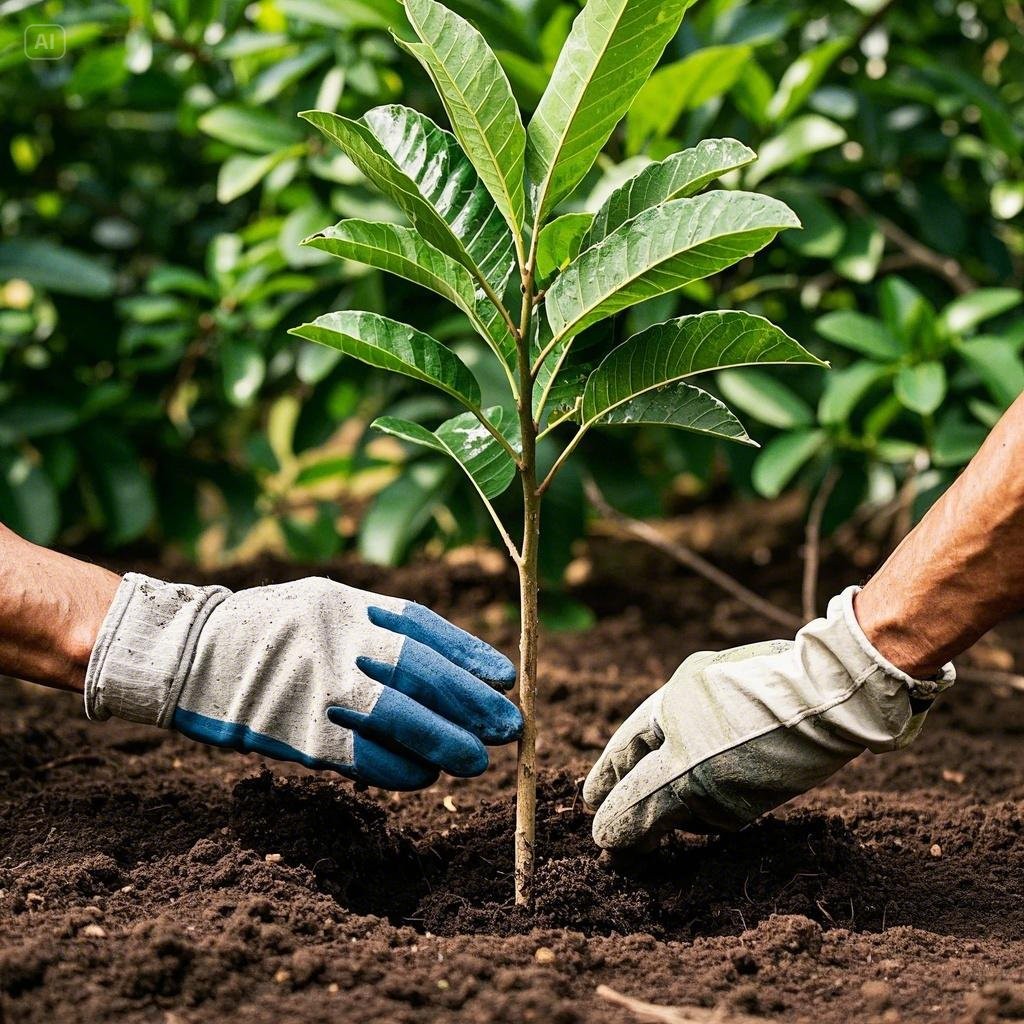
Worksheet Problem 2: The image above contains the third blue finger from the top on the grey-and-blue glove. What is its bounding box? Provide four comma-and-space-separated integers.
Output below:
327, 687, 487, 778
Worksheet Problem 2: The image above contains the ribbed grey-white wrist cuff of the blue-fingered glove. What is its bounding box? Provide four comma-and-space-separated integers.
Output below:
85, 572, 231, 728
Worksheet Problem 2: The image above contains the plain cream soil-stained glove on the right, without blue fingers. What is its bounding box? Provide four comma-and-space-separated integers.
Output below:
583, 587, 955, 850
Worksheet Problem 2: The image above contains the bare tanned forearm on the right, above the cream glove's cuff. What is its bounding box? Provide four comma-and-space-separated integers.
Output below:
855, 395, 1024, 678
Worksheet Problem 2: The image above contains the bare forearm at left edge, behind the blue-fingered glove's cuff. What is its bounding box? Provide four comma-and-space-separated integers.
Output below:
0, 525, 120, 692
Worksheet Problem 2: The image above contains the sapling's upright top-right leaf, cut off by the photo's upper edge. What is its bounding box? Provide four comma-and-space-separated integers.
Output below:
526, 0, 693, 221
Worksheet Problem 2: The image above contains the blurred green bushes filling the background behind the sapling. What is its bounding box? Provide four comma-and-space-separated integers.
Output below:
0, 0, 1024, 578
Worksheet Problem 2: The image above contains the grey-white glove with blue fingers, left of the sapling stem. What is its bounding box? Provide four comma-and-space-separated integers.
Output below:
85, 572, 522, 790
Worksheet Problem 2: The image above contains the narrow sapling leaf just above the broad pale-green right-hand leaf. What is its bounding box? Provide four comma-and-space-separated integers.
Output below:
581, 138, 757, 249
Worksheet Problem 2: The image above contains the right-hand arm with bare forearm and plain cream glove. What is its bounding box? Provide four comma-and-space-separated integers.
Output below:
584, 398, 1024, 849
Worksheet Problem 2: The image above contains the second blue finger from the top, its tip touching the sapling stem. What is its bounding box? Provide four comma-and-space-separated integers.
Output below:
355, 638, 522, 745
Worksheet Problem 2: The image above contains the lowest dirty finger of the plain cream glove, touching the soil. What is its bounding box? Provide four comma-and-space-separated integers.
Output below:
593, 748, 690, 850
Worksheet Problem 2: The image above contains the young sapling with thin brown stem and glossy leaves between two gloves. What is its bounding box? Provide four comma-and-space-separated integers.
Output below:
292, 0, 819, 904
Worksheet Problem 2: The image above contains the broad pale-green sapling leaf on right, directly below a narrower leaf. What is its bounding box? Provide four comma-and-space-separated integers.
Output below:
545, 191, 800, 342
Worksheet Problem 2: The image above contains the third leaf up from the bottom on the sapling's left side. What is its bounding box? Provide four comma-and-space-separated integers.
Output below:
303, 219, 515, 360
